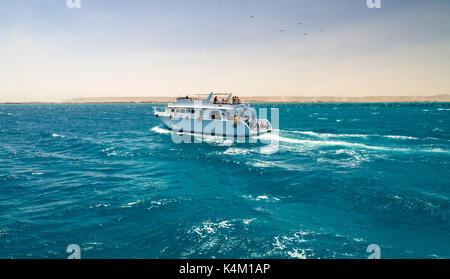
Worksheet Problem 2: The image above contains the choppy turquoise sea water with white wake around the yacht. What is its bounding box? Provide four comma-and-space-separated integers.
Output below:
0, 103, 450, 258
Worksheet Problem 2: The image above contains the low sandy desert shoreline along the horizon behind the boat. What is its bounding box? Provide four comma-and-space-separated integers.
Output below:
0, 94, 450, 104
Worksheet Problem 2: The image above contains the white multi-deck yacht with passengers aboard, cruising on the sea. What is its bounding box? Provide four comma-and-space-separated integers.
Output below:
154, 93, 272, 137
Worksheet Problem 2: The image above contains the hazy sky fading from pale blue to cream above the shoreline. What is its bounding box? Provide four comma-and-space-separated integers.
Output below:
0, 0, 450, 102
